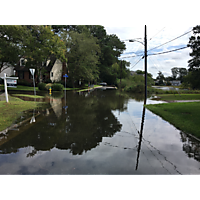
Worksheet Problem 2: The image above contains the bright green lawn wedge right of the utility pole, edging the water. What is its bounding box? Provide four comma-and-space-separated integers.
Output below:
145, 102, 200, 138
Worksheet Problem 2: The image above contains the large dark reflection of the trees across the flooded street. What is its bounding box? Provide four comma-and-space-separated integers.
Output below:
0, 91, 127, 156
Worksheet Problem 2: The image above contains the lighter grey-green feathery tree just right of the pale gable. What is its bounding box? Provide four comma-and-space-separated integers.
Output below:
61, 31, 101, 86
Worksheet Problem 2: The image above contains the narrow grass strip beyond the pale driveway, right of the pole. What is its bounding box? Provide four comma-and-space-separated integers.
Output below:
155, 94, 200, 101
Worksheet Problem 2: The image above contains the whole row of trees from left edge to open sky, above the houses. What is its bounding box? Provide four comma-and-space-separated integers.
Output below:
0, 25, 130, 86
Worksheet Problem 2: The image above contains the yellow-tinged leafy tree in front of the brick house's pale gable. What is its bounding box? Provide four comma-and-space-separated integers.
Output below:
23, 25, 67, 82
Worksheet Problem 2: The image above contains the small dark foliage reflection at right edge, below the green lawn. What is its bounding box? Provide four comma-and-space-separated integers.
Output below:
180, 132, 200, 161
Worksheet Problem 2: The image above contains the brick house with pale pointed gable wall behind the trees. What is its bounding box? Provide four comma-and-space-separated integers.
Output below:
14, 56, 66, 83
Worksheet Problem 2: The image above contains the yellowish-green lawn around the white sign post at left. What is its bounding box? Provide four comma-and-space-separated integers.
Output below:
0, 96, 41, 131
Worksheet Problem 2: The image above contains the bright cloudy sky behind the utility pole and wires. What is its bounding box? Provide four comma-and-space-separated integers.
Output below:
103, 25, 195, 78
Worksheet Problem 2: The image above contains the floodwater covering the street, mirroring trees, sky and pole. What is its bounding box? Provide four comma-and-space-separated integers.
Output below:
0, 90, 200, 174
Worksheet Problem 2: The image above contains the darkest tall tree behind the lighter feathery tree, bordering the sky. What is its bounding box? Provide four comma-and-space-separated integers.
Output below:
52, 25, 126, 84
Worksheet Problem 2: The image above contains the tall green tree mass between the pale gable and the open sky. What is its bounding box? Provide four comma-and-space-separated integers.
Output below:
52, 25, 130, 86
